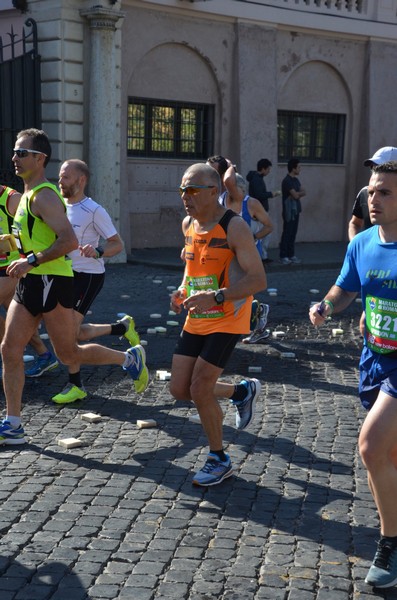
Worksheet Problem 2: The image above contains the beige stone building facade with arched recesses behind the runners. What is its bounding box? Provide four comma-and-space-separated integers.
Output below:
0, 0, 397, 253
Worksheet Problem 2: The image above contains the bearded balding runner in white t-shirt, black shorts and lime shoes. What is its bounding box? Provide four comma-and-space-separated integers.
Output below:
26, 159, 139, 404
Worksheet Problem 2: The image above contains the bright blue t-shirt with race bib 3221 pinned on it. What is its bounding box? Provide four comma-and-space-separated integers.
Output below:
336, 225, 397, 354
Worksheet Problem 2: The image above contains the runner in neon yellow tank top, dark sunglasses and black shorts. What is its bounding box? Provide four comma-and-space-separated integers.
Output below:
0, 129, 149, 445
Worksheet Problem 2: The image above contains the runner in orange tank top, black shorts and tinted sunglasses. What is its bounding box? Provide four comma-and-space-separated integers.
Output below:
170, 164, 266, 486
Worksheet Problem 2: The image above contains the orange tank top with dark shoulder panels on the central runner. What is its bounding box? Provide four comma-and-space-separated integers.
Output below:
184, 210, 252, 335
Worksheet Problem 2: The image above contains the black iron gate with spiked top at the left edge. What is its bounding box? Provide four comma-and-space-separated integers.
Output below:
0, 19, 41, 191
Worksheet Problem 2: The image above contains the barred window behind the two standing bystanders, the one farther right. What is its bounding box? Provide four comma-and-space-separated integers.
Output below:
277, 110, 346, 164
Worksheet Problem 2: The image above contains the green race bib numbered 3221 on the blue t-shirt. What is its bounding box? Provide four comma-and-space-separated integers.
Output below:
365, 296, 397, 354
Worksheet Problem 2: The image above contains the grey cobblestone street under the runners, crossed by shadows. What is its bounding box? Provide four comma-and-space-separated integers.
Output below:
0, 264, 397, 600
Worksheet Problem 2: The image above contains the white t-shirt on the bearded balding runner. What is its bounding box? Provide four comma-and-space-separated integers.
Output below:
65, 197, 117, 273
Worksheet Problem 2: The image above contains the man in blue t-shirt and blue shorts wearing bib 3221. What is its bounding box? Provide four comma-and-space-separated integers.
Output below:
309, 161, 397, 588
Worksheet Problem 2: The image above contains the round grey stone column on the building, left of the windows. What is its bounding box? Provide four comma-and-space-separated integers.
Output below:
80, 6, 126, 262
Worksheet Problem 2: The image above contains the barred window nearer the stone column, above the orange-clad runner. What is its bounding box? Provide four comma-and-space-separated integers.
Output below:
127, 97, 215, 159
